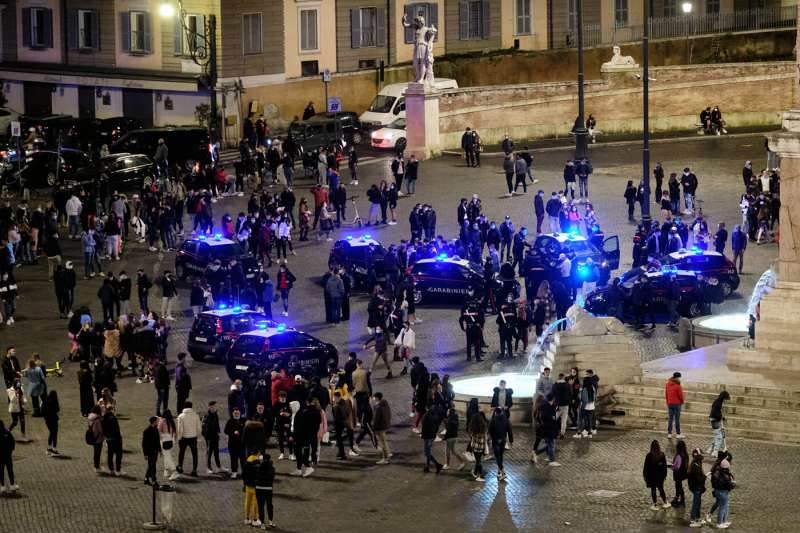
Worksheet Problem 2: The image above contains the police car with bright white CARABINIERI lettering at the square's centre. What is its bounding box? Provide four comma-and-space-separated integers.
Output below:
411, 254, 519, 304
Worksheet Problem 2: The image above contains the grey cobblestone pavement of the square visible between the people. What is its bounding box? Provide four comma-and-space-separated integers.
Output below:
0, 136, 800, 533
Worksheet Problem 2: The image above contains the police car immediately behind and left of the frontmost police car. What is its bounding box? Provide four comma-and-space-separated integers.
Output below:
186, 304, 274, 361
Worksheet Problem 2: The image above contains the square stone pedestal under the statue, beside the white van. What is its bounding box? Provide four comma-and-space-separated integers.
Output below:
405, 83, 441, 160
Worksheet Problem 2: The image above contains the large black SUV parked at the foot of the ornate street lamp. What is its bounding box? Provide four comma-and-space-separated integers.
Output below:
110, 126, 211, 169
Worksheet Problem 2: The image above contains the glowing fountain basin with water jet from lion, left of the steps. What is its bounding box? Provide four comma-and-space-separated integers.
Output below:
452, 318, 567, 423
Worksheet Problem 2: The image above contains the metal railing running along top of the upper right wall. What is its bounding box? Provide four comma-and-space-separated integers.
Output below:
553, 5, 797, 48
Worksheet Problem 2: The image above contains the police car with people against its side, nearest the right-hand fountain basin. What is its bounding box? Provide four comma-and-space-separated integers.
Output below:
584, 266, 708, 318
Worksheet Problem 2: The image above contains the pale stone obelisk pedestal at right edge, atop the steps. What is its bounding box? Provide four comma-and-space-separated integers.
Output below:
727, 109, 800, 371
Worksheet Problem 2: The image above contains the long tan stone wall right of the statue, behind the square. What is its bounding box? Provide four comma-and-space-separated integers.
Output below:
439, 62, 795, 149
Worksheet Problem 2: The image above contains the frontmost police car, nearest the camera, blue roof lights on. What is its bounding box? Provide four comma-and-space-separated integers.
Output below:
225, 322, 339, 380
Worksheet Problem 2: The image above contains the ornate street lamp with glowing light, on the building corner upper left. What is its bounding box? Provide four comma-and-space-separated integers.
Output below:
158, 0, 219, 144
